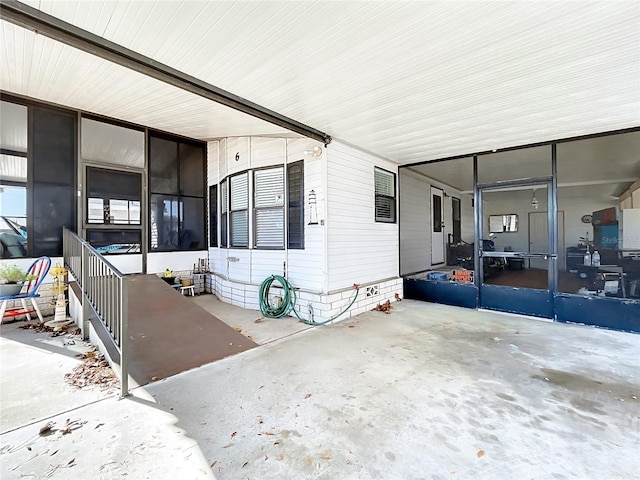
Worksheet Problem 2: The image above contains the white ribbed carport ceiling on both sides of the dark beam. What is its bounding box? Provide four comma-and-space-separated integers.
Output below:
1, 0, 640, 164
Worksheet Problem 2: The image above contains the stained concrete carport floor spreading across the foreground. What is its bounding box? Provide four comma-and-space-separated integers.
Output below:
0, 300, 640, 480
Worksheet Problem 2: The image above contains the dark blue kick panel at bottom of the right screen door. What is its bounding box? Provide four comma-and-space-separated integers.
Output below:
480, 285, 553, 318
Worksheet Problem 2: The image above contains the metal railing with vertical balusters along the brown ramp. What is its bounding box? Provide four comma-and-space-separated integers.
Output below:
62, 227, 129, 397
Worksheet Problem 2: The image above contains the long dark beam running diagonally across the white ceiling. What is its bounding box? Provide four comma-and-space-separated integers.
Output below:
0, 0, 331, 145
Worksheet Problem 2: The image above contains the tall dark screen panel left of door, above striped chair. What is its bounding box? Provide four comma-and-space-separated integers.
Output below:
30, 107, 76, 257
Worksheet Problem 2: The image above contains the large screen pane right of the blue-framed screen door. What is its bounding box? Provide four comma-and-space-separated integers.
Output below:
557, 132, 640, 299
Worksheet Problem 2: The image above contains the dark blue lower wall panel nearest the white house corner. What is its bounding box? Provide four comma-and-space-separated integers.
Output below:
404, 278, 478, 308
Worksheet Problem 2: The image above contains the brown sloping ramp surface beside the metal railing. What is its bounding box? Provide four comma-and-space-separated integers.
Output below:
127, 275, 258, 385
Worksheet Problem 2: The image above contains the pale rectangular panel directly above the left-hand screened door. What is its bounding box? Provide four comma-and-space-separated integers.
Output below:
82, 118, 144, 168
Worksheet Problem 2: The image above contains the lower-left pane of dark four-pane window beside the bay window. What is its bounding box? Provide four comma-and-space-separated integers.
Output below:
149, 194, 180, 251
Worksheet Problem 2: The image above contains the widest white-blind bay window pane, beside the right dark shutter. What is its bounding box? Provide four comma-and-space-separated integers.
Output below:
253, 167, 284, 248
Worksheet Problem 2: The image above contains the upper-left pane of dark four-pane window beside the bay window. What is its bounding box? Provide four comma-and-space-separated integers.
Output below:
149, 137, 178, 195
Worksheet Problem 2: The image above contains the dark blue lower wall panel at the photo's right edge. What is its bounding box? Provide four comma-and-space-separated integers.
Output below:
555, 293, 640, 333
